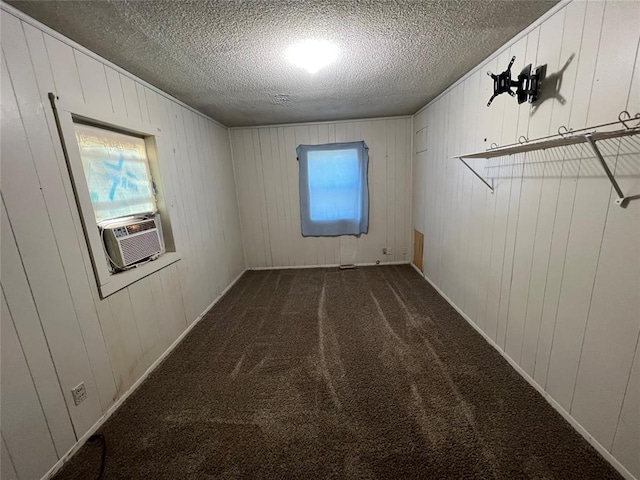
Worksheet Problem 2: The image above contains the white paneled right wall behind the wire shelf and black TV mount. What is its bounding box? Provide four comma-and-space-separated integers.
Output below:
413, 1, 640, 477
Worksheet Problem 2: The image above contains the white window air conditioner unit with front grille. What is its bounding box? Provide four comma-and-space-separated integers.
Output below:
102, 218, 162, 270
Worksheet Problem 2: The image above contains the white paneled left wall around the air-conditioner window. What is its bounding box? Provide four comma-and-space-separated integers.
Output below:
1, 6, 245, 479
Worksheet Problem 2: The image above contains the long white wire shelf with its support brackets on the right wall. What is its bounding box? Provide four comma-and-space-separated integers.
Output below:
453, 111, 640, 208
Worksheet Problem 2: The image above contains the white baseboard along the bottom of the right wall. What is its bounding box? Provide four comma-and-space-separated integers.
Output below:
411, 263, 638, 480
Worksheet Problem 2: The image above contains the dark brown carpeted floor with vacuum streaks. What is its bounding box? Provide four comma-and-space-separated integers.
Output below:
55, 265, 621, 480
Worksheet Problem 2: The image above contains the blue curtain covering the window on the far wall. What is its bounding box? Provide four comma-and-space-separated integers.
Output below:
296, 142, 369, 237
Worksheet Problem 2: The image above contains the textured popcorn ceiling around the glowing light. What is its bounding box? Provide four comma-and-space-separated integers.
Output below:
8, 0, 556, 126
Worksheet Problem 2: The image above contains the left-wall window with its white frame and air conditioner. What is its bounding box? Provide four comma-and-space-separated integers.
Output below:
49, 93, 180, 298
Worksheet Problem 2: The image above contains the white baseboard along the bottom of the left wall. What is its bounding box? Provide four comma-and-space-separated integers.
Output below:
41, 269, 247, 480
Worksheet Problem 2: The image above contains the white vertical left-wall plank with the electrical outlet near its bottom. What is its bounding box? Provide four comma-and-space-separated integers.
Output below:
1, 42, 101, 436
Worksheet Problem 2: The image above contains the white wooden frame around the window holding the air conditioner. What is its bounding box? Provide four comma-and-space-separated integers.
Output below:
49, 93, 181, 299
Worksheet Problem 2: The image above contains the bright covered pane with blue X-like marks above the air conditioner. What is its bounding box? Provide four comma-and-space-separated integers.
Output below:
74, 123, 156, 225
